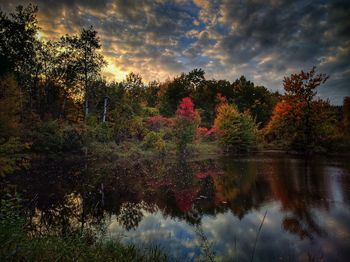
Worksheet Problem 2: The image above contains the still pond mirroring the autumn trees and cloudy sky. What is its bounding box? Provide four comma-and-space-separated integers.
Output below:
2, 153, 350, 261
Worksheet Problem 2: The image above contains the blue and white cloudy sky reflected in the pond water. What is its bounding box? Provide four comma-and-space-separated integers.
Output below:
109, 199, 350, 261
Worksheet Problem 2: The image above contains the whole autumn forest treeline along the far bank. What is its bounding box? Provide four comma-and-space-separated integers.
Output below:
0, 5, 350, 166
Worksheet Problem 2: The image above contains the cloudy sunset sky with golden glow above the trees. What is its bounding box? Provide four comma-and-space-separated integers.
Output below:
0, 0, 350, 104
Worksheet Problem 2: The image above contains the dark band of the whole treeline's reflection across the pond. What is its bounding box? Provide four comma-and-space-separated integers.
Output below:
9, 152, 342, 243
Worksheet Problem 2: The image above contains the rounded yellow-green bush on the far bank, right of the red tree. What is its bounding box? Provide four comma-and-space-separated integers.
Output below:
214, 103, 257, 152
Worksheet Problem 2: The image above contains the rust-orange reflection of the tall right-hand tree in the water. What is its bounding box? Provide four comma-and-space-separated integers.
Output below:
268, 160, 328, 239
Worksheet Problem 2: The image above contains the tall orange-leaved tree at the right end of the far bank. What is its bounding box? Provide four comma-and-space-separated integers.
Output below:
267, 67, 336, 153
